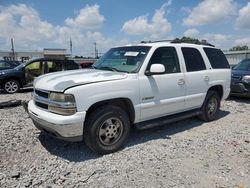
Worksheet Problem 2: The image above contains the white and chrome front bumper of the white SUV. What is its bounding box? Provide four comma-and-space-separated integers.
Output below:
28, 100, 86, 141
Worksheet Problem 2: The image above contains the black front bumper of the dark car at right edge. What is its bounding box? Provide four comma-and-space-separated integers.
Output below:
230, 82, 250, 96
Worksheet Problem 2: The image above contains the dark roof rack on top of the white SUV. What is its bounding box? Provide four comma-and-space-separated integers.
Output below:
141, 38, 215, 47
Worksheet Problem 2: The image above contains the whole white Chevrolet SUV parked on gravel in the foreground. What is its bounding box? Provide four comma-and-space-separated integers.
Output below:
28, 41, 231, 154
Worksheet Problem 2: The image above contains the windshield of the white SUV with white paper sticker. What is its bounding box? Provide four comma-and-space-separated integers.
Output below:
93, 46, 150, 73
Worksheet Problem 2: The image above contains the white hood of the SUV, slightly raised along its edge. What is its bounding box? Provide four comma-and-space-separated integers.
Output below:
34, 69, 127, 92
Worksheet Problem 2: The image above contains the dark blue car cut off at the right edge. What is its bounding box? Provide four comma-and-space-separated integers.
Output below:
231, 59, 250, 97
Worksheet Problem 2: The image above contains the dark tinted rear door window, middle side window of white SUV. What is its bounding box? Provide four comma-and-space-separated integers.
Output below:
181, 48, 206, 72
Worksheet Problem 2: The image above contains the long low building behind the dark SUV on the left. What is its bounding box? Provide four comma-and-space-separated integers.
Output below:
0, 48, 69, 62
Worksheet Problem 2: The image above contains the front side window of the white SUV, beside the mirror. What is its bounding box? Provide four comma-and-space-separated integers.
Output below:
148, 47, 180, 73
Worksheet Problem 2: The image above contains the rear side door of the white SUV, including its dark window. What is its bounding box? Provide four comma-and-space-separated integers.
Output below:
181, 47, 210, 110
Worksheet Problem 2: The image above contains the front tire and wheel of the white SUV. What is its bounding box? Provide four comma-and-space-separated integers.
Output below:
83, 105, 130, 155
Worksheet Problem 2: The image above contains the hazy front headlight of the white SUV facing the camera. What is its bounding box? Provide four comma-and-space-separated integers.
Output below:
48, 92, 76, 115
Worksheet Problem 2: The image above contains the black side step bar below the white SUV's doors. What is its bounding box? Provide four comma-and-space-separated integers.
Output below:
135, 109, 202, 130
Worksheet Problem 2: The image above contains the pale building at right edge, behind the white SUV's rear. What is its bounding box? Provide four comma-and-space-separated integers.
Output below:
224, 50, 250, 66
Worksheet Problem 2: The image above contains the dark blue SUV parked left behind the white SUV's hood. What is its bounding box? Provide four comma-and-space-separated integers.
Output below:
0, 58, 80, 93
